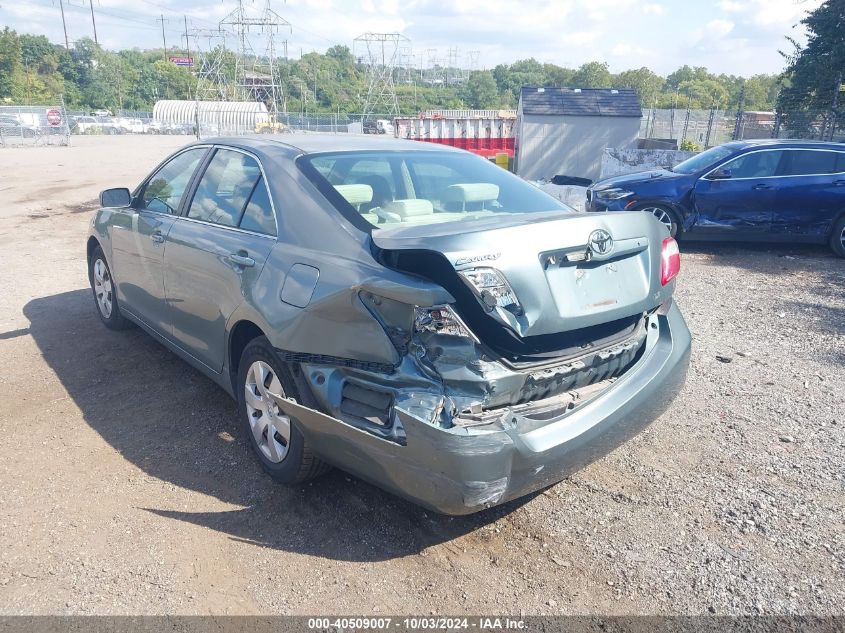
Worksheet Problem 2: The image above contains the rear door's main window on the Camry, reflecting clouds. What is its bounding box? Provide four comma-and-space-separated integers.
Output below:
188, 149, 261, 227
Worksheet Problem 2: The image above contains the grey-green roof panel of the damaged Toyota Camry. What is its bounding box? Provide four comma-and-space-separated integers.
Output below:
195, 133, 461, 154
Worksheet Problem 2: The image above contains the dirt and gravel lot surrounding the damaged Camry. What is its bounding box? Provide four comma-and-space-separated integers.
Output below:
0, 137, 845, 614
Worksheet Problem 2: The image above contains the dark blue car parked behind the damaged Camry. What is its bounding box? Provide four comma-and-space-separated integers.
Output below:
587, 140, 845, 257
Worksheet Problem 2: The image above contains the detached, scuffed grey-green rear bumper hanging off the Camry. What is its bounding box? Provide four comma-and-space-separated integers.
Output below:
276, 305, 691, 515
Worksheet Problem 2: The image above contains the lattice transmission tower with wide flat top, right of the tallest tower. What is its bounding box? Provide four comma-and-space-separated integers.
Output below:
353, 33, 411, 118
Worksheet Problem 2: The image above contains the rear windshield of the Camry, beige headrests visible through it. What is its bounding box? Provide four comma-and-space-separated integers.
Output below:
300, 151, 572, 228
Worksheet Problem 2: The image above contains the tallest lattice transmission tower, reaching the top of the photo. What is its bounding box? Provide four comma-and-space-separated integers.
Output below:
220, 0, 291, 113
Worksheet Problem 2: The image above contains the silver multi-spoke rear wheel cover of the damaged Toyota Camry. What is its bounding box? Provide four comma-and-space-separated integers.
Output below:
244, 360, 290, 464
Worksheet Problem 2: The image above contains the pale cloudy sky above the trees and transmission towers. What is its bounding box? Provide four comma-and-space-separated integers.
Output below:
0, 0, 821, 76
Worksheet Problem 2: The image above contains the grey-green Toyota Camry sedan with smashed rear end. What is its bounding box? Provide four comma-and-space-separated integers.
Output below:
87, 135, 690, 514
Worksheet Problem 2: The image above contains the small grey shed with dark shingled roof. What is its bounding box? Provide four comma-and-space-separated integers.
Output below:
516, 88, 643, 180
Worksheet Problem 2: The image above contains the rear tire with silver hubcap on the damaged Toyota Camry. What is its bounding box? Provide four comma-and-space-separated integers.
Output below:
237, 336, 331, 484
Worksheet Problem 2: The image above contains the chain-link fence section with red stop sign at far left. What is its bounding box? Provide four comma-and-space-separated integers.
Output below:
0, 103, 70, 147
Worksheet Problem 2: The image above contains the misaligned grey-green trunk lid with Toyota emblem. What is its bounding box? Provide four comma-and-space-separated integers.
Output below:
372, 213, 673, 349
